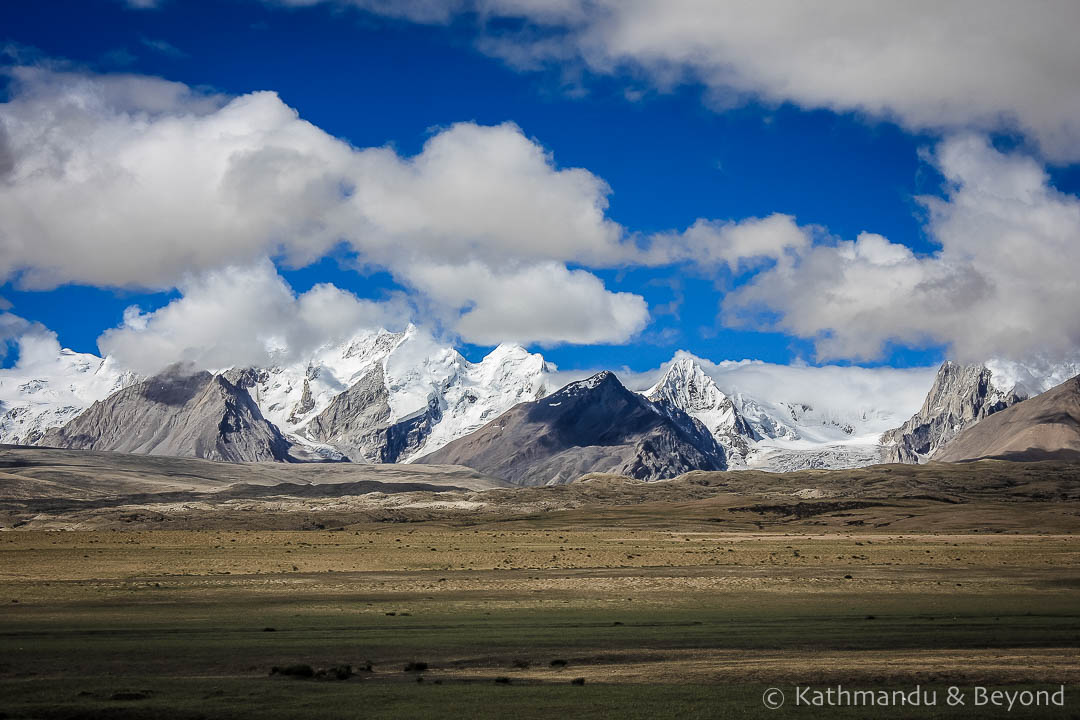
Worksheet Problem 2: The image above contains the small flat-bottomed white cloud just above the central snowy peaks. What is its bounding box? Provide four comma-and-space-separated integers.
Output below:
408, 262, 649, 345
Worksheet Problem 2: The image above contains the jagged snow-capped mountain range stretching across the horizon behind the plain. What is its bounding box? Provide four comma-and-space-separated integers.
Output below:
0, 326, 1080, 484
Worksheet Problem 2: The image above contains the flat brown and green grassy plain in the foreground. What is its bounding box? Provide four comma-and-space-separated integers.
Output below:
0, 524, 1080, 720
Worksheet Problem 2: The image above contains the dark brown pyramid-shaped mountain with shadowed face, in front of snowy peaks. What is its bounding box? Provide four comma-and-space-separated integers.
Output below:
419, 372, 725, 485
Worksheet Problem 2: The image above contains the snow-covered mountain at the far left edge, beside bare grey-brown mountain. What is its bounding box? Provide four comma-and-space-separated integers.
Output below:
0, 336, 138, 445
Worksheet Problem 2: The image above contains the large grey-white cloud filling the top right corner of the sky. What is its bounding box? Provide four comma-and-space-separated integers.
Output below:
270, 0, 1080, 162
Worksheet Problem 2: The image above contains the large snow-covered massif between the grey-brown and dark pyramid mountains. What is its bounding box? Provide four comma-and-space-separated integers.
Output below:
234, 325, 552, 462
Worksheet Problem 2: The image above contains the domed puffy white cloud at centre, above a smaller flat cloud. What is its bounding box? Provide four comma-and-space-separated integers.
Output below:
336, 123, 632, 264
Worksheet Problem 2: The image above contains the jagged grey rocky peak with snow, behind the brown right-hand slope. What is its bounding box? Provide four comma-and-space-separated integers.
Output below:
881, 359, 1080, 463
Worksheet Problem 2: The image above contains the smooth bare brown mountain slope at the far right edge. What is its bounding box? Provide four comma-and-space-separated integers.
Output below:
934, 376, 1080, 462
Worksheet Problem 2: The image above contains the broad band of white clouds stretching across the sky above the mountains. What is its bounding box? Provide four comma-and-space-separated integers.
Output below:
0, 59, 1080, 368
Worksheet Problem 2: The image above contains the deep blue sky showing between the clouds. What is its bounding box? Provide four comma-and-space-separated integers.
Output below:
0, 0, 1080, 370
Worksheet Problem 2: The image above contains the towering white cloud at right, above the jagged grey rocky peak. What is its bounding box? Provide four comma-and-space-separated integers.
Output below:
724, 135, 1080, 361
